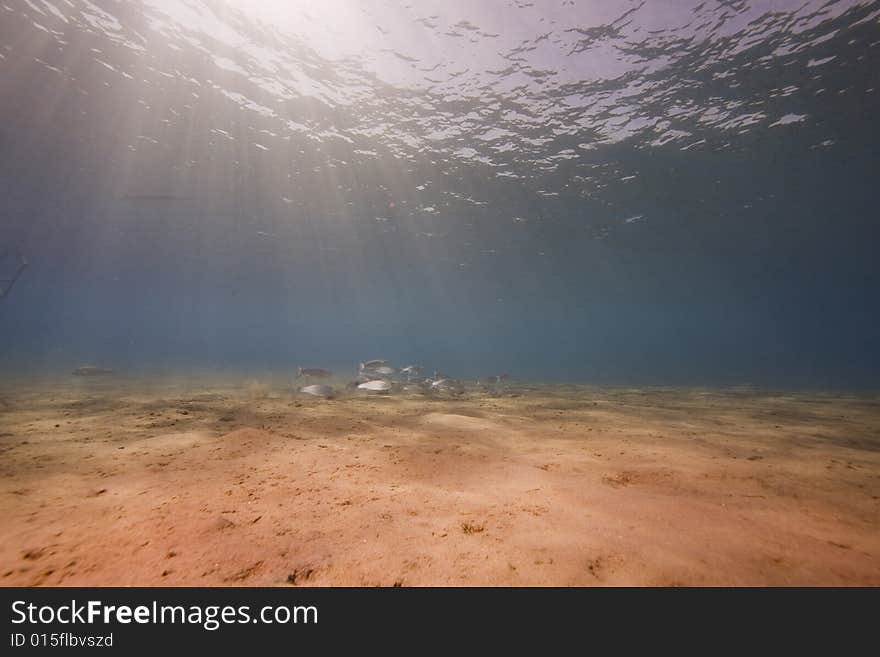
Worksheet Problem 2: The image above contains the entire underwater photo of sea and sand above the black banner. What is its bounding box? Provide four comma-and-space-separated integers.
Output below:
0, 0, 880, 587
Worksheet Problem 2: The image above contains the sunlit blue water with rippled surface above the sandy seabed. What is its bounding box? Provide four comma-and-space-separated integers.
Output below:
0, 0, 880, 388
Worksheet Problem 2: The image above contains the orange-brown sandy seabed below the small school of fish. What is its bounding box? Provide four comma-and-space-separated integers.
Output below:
0, 376, 880, 586
